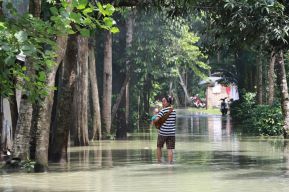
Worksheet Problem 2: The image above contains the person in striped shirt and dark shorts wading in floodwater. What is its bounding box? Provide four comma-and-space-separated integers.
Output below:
154, 96, 176, 164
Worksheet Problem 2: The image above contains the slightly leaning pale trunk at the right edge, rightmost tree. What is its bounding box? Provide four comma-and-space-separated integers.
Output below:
276, 50, 289, 139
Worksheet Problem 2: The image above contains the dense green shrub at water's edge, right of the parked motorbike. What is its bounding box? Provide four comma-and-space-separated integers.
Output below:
231, 93, 283, 136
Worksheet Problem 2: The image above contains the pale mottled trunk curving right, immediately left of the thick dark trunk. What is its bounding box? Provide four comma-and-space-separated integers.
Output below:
35, 36, 67, 172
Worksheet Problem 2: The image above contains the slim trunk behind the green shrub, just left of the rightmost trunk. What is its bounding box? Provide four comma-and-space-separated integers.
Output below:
268, 49, 276, 105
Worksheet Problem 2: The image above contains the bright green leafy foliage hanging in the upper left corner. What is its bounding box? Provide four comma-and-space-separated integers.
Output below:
0, 0, 118, 100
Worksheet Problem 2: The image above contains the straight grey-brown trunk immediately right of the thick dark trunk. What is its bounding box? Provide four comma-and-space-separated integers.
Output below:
74, 36, 89, 146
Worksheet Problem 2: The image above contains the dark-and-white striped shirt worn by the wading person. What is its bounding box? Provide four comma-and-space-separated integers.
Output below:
158, 107, 177, 136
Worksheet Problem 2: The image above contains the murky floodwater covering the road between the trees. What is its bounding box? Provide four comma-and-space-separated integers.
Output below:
0, 111, 289, 192
